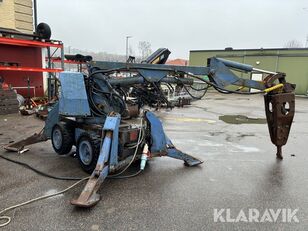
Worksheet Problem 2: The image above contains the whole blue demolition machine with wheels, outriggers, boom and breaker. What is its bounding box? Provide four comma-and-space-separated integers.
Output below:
5, 50, 295, 207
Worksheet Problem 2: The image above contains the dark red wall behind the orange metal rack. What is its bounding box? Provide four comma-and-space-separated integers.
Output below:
0, 44, 44, 97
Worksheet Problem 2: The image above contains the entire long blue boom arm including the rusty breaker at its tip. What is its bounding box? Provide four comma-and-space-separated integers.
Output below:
92, 57, 295, 159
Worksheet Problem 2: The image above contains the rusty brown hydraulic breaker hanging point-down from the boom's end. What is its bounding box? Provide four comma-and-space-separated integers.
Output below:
264, 93, 295, 159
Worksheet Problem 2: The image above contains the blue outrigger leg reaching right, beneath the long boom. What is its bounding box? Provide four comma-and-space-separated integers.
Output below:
145, 112, 203, 166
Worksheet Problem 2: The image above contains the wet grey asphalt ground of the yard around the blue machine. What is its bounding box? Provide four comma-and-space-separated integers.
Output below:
0, 94, 308, 230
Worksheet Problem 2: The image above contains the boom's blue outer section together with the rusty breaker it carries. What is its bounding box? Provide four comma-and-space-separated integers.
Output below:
209, 58, 295, 159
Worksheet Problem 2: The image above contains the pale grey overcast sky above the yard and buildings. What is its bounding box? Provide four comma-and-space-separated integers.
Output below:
37, 0, 308, 58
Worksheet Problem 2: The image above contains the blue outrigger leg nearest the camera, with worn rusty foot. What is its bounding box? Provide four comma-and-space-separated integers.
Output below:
71, 115, 120, 207
